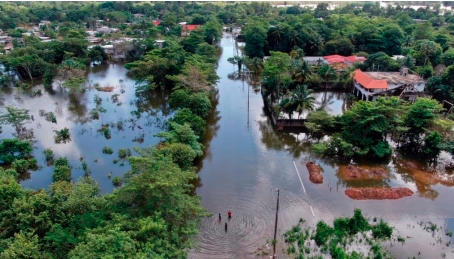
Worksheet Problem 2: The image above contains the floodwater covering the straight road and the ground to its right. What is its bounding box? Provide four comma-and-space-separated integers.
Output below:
189, 35, 454, 259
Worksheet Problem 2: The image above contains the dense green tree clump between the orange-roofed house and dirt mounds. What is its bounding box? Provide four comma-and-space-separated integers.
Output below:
308, 97, 446, 159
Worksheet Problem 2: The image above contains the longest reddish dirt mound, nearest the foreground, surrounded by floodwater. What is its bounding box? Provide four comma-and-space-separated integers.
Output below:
345, 187, 413, 200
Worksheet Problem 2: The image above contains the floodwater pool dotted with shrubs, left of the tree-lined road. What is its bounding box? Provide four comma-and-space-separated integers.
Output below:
0, 64, 172, 192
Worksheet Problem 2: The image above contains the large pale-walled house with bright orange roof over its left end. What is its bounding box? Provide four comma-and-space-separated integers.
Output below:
351, 67, 426, 101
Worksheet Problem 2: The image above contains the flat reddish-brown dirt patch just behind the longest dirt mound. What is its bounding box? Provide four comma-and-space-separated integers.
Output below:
338, 165, 389, 181
